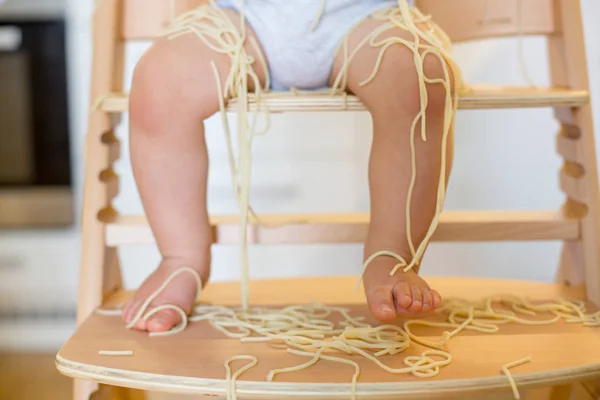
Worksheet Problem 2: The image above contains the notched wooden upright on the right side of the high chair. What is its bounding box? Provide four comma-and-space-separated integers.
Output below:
548, 0, 600, 305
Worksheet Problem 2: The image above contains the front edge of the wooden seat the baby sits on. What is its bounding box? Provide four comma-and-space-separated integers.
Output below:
100, 85, 589, 113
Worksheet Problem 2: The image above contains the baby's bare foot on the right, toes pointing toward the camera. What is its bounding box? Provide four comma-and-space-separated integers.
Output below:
363, 257, 442, 321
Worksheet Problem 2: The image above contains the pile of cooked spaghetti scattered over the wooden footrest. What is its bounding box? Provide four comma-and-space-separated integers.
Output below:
98, 268, 600, 398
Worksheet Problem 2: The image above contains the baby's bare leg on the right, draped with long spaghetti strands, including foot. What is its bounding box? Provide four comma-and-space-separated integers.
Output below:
333, 19, 452, 320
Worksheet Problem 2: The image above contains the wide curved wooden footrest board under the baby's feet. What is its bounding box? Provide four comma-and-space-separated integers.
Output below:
57, 277, 600, 399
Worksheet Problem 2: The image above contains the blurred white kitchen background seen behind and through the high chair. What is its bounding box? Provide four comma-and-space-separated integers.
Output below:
0, 0, 600, 350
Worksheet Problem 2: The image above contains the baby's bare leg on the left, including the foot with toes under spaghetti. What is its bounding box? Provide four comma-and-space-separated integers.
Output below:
123, 10, 266, 332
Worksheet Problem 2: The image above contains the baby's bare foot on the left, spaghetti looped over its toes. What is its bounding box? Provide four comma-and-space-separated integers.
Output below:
123, 259, 210, 332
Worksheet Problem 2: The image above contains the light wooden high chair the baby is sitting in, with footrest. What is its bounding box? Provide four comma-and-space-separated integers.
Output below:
57, 0, 600, 400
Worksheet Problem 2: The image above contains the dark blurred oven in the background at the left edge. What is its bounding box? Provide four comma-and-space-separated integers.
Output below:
0, 19, 74, 229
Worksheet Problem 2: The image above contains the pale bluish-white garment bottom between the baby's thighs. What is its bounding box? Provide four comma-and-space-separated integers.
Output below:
217, 0, 413, 90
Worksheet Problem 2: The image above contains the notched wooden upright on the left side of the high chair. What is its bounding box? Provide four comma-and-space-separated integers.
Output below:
74, 0, 125, 400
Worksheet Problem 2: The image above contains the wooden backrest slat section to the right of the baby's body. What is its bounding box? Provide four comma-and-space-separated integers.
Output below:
417, 0, 559, 43
